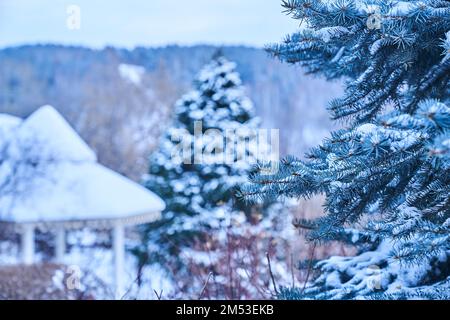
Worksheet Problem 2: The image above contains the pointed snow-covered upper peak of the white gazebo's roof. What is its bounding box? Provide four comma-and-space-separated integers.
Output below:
14, 105, 97, 162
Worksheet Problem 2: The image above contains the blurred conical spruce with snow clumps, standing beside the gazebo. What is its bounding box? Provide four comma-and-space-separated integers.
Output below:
137, 55, 270, 280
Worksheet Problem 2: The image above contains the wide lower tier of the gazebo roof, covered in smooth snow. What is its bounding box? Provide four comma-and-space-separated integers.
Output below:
0, 163, 164, 229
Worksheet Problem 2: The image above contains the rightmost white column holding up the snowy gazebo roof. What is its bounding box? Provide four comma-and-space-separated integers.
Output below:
113, 221, 125, 299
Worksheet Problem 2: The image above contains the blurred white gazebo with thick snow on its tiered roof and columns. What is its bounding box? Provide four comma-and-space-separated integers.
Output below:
0, 106, 165, 298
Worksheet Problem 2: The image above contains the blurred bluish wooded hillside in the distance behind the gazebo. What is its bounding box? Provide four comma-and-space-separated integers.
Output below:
0, 45, 341, 179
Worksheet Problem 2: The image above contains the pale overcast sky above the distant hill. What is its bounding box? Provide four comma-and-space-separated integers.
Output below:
0, 0, 298, 48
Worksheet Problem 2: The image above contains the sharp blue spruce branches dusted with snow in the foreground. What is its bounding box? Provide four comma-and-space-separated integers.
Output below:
242, 0, 450, 299
